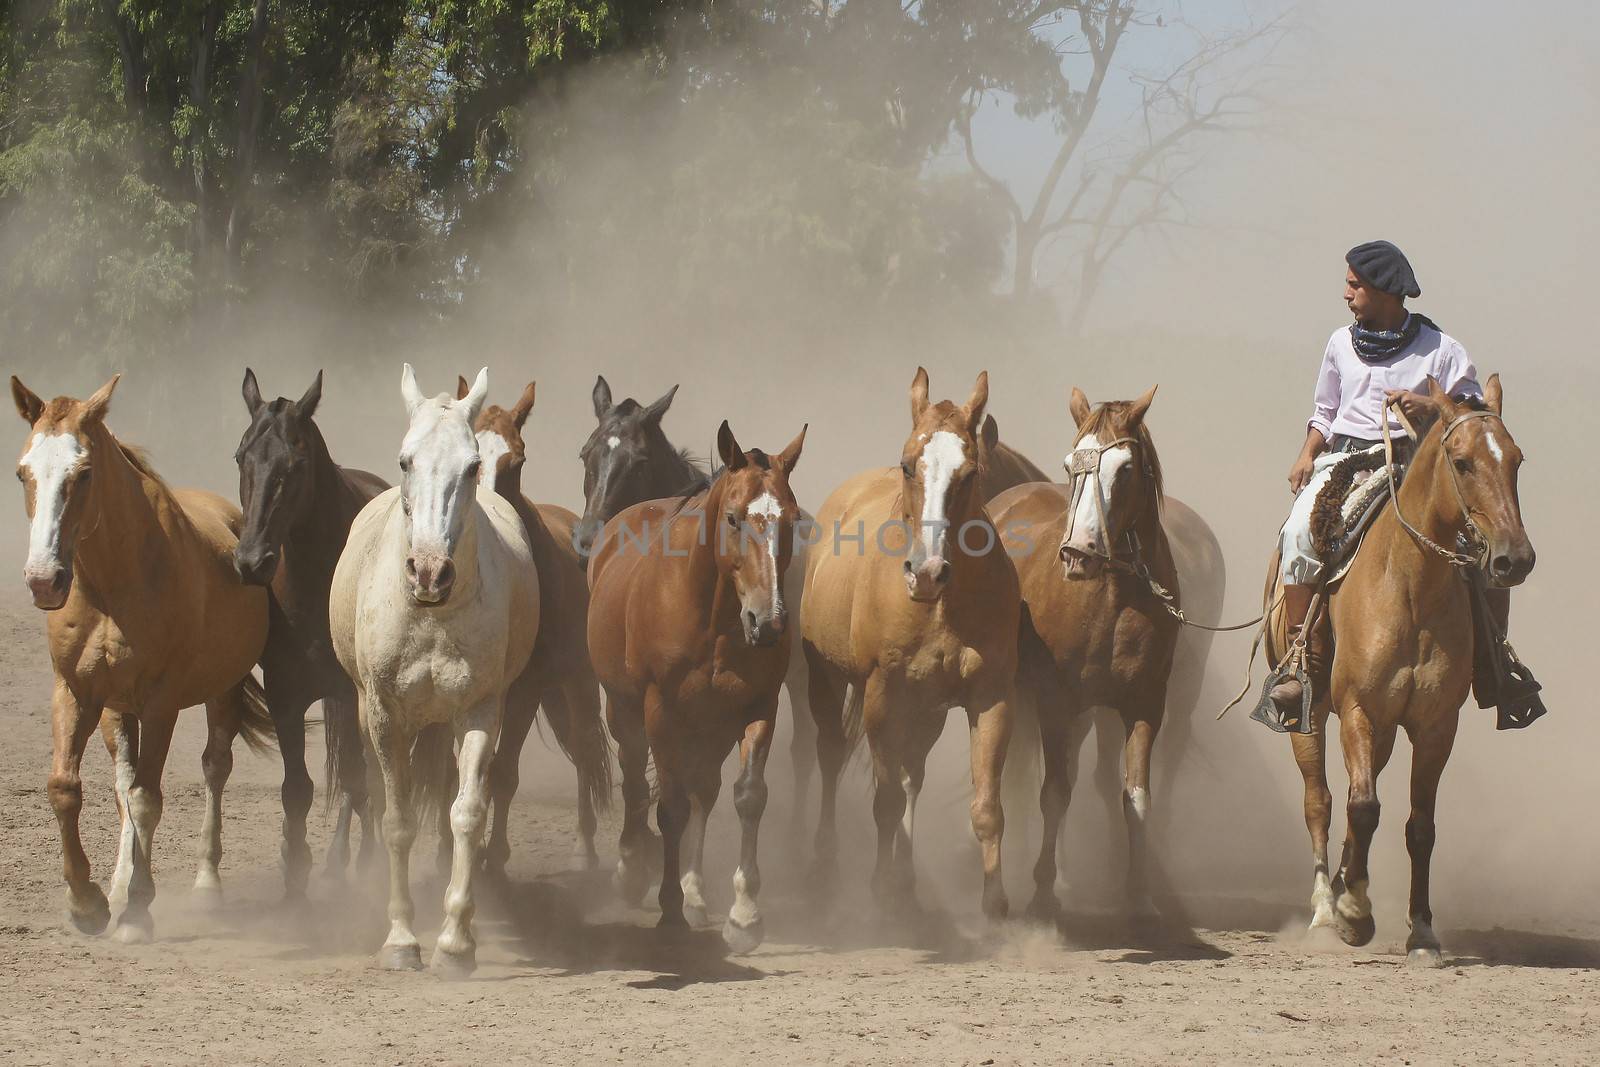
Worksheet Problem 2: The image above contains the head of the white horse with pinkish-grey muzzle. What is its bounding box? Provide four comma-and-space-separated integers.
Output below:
400, 363, 490, 605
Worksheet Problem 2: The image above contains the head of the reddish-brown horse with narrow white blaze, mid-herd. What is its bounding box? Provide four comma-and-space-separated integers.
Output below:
707, 419, 805, 646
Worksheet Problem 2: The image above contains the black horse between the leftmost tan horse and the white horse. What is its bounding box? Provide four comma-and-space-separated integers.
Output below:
234, 368, 389, 897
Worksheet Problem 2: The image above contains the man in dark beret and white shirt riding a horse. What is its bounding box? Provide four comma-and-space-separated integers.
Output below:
1269, 242, 1542, 725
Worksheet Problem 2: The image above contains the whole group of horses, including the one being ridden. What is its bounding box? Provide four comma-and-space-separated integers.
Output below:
11, 365, 1531, 973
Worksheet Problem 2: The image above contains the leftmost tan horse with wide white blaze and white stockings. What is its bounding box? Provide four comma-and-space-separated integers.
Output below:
11, 378, 270, 942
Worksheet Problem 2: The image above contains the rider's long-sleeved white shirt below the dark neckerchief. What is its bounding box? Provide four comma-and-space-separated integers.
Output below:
1306, 314, 1483, 442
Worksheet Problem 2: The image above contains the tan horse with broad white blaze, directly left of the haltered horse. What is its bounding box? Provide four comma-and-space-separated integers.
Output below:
802, 368, 1019, 917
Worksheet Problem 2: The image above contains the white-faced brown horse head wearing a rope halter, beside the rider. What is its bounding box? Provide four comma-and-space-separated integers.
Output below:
1061, 386, 1162, 579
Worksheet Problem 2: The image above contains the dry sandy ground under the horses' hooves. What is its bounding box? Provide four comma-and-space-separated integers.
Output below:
0, 597, 1600, 1064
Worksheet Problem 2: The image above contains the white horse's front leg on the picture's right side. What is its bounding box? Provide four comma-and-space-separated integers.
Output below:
430, 697, 506, 977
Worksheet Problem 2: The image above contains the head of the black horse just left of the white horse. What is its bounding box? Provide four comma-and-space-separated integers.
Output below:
234, 366, 322, 585
